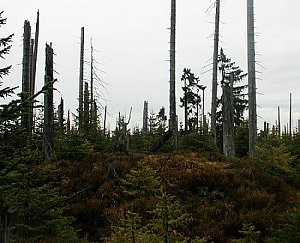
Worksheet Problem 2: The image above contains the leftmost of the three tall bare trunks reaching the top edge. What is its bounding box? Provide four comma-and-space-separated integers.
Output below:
169, 0, 177, 142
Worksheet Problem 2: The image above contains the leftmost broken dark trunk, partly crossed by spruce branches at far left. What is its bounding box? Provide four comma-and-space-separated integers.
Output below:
21, 20, 31, 131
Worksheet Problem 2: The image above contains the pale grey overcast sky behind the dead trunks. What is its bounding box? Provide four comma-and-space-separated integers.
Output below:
0, 0, 300, 132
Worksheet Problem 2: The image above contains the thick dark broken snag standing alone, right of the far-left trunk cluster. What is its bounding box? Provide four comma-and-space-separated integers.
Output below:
44, 44, 54, 160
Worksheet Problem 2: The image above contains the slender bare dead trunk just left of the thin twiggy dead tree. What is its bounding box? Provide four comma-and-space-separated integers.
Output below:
78, 27, 84, 130
